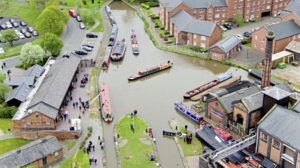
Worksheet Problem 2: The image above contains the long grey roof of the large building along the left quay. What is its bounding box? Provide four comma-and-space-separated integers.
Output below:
25, 56, 81, 118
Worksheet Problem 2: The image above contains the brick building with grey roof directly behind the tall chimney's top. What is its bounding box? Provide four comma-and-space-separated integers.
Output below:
252, 20, 300, 54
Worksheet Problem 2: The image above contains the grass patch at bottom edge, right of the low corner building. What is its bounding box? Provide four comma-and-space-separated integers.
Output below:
59, 150, 90, 168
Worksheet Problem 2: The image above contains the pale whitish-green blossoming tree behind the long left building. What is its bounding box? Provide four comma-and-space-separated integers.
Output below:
21, 43, 45, 66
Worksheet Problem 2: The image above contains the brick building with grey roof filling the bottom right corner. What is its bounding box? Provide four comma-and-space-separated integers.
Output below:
256, 105, 300, 168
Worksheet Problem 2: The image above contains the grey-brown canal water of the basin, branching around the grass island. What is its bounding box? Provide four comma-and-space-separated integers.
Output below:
99, 1, 247, 168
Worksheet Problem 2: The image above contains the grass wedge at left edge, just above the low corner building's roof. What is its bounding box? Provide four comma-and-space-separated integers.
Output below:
0, 138, 30, 155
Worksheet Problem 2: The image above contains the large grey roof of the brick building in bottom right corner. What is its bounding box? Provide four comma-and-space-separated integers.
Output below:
259, 105, 300, 151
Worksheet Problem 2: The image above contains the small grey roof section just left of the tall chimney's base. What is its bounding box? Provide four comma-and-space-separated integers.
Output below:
241, 92, 264, 112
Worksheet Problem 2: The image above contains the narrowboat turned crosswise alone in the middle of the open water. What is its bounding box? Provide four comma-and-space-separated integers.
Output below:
128, 61, 173, 81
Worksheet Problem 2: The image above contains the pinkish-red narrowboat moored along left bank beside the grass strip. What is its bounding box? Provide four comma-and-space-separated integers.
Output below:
99, 83, 113, 123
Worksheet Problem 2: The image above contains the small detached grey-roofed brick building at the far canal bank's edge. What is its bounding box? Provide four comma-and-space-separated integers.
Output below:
208, 36, 242, 61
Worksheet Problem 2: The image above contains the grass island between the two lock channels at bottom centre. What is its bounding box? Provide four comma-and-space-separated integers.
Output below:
116, 115, 155, 168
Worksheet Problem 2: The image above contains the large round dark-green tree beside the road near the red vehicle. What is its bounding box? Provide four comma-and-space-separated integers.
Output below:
36, 8, 65, 35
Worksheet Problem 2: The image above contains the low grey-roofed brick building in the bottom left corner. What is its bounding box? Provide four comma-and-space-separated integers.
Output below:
0, 136, 64, 168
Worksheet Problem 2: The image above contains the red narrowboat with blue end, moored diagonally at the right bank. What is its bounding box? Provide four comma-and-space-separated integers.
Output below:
183, 73, 232, 99
